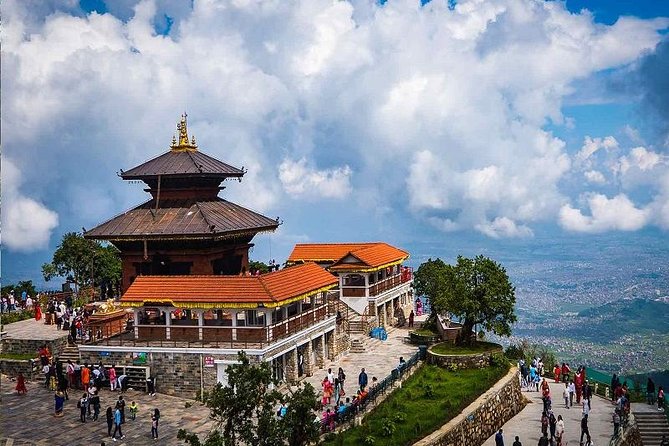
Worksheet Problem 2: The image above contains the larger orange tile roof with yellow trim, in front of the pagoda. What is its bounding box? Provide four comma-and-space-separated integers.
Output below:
121, 263, 337, 308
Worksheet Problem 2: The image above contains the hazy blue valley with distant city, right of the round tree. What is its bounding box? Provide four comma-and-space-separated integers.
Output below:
412, 230, 669, 374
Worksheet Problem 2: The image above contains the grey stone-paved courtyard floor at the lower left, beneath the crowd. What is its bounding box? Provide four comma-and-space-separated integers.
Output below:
0, 375, 213, 446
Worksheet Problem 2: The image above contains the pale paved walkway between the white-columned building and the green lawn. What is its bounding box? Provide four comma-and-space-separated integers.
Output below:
305, 328, 418, 401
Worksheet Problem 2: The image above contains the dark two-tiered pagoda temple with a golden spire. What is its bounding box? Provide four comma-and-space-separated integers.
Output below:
84, 114, 279, 292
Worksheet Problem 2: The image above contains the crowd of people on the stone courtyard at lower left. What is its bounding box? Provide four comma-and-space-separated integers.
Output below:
16, 352, 160, 441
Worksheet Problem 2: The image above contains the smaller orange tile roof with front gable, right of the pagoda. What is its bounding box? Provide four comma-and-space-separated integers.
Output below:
288, 242, 409, 270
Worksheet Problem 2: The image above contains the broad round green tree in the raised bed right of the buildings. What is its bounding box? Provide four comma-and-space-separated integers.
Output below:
414, 255, 516, 344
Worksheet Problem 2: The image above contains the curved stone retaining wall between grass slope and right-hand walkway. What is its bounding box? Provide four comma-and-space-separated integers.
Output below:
414, 367, 526, 446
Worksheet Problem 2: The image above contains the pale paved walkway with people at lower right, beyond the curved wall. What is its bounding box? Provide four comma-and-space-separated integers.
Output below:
482, 382, 614, 446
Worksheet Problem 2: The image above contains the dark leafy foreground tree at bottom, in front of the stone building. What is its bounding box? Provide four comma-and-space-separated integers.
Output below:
177, 352, 319, 446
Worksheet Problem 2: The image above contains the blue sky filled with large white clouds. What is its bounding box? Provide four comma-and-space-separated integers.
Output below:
2, 0, 669, 288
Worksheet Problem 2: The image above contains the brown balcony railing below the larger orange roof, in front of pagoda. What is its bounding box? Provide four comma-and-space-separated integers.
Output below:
90, 305, 328, 348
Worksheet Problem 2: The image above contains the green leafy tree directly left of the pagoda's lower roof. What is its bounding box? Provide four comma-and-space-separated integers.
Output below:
42, 232, 121, 294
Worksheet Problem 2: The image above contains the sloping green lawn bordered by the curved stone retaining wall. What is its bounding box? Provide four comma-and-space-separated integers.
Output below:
324, 364, 508, 446
